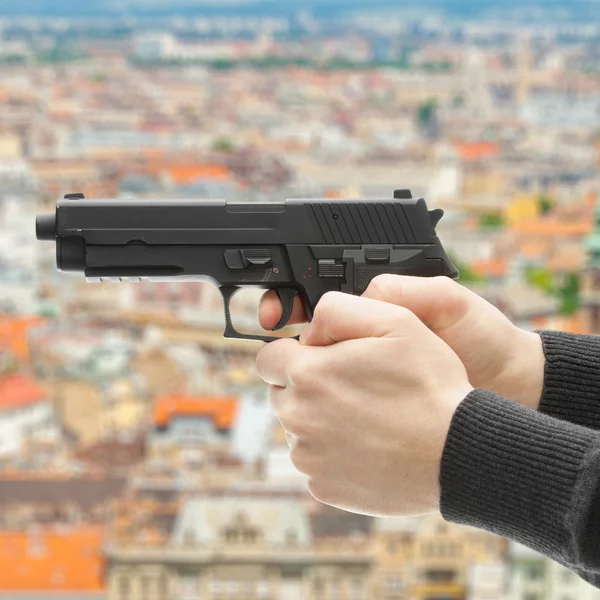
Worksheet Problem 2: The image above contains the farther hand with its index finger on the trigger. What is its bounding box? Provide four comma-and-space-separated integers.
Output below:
259, 275, 546, 410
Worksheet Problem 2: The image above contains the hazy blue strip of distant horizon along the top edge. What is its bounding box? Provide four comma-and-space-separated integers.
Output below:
0, 0, 600, 19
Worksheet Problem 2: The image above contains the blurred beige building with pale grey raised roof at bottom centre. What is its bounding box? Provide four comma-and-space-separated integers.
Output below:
107, 497, 372, 600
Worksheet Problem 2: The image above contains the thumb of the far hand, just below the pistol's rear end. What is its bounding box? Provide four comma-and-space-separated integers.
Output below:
363, 275, 476, 333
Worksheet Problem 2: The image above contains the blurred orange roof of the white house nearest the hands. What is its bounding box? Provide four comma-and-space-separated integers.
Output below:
154, 394, 238, 429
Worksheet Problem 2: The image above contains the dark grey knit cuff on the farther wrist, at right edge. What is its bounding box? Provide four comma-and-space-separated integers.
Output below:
538, 331, 600, 429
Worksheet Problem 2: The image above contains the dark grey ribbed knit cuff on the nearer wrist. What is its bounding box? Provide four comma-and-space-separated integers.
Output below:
440, 390, 596, 561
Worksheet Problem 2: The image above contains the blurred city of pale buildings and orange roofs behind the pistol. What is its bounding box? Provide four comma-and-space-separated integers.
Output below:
0, 3, 600, 600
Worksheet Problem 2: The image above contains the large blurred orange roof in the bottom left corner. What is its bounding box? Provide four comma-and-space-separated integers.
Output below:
0, 526, 104, 595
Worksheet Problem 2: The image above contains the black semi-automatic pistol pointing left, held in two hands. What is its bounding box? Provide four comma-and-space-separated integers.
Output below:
36, 189, 458, 342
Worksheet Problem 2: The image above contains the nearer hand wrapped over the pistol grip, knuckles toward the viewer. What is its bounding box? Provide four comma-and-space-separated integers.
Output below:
257, 293, 473, 516
